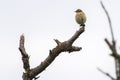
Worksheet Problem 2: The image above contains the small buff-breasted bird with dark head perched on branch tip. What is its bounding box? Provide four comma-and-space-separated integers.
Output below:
75, 9, 86, 26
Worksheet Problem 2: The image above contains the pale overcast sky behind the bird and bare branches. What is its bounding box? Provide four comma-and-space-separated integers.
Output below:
0, 0, 120, 80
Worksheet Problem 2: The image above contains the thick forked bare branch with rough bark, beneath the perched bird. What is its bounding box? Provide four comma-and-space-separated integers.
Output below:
19, 27, 84, 80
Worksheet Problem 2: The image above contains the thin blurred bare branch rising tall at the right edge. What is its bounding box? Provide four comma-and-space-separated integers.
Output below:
100, 1, 120, 80
